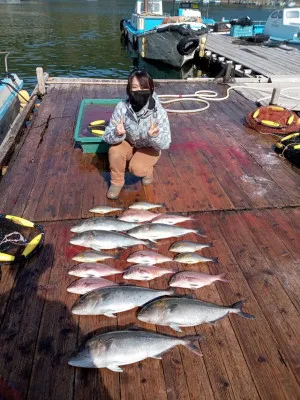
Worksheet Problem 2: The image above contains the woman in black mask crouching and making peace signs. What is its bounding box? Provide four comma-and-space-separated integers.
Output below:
103, 70, 171, 199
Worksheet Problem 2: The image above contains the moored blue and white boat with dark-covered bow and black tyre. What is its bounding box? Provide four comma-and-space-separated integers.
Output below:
120, 0, 207, 68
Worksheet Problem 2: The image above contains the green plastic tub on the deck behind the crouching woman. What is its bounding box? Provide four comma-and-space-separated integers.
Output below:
74, 99, 121, 153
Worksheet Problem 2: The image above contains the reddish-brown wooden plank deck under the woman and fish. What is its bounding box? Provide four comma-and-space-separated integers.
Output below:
0, 82, 300, 400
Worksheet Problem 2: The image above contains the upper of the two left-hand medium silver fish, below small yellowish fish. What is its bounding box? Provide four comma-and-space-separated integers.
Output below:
71, 217, 139, 233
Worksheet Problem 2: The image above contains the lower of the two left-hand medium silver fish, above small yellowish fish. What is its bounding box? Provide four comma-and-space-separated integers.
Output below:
70, 231, 153, 250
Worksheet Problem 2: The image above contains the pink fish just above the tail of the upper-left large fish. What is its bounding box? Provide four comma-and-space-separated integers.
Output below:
123, 264, 177, 281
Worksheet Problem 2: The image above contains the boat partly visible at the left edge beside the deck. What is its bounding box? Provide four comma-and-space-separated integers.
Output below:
0, 52, 23, 145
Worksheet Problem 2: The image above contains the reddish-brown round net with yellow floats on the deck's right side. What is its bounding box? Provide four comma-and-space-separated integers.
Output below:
246, 105, 300, 135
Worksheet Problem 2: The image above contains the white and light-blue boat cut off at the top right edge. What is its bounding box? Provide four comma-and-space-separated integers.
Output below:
264, 7, 300, 44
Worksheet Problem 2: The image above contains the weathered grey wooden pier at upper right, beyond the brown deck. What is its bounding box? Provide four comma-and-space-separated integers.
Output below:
205, 33, 300, 79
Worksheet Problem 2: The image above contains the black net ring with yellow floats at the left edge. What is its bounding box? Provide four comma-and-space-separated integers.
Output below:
0, 214, 45, 264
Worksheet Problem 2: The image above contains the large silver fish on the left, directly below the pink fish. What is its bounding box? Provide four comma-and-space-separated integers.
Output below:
71, 285, 174, 317
